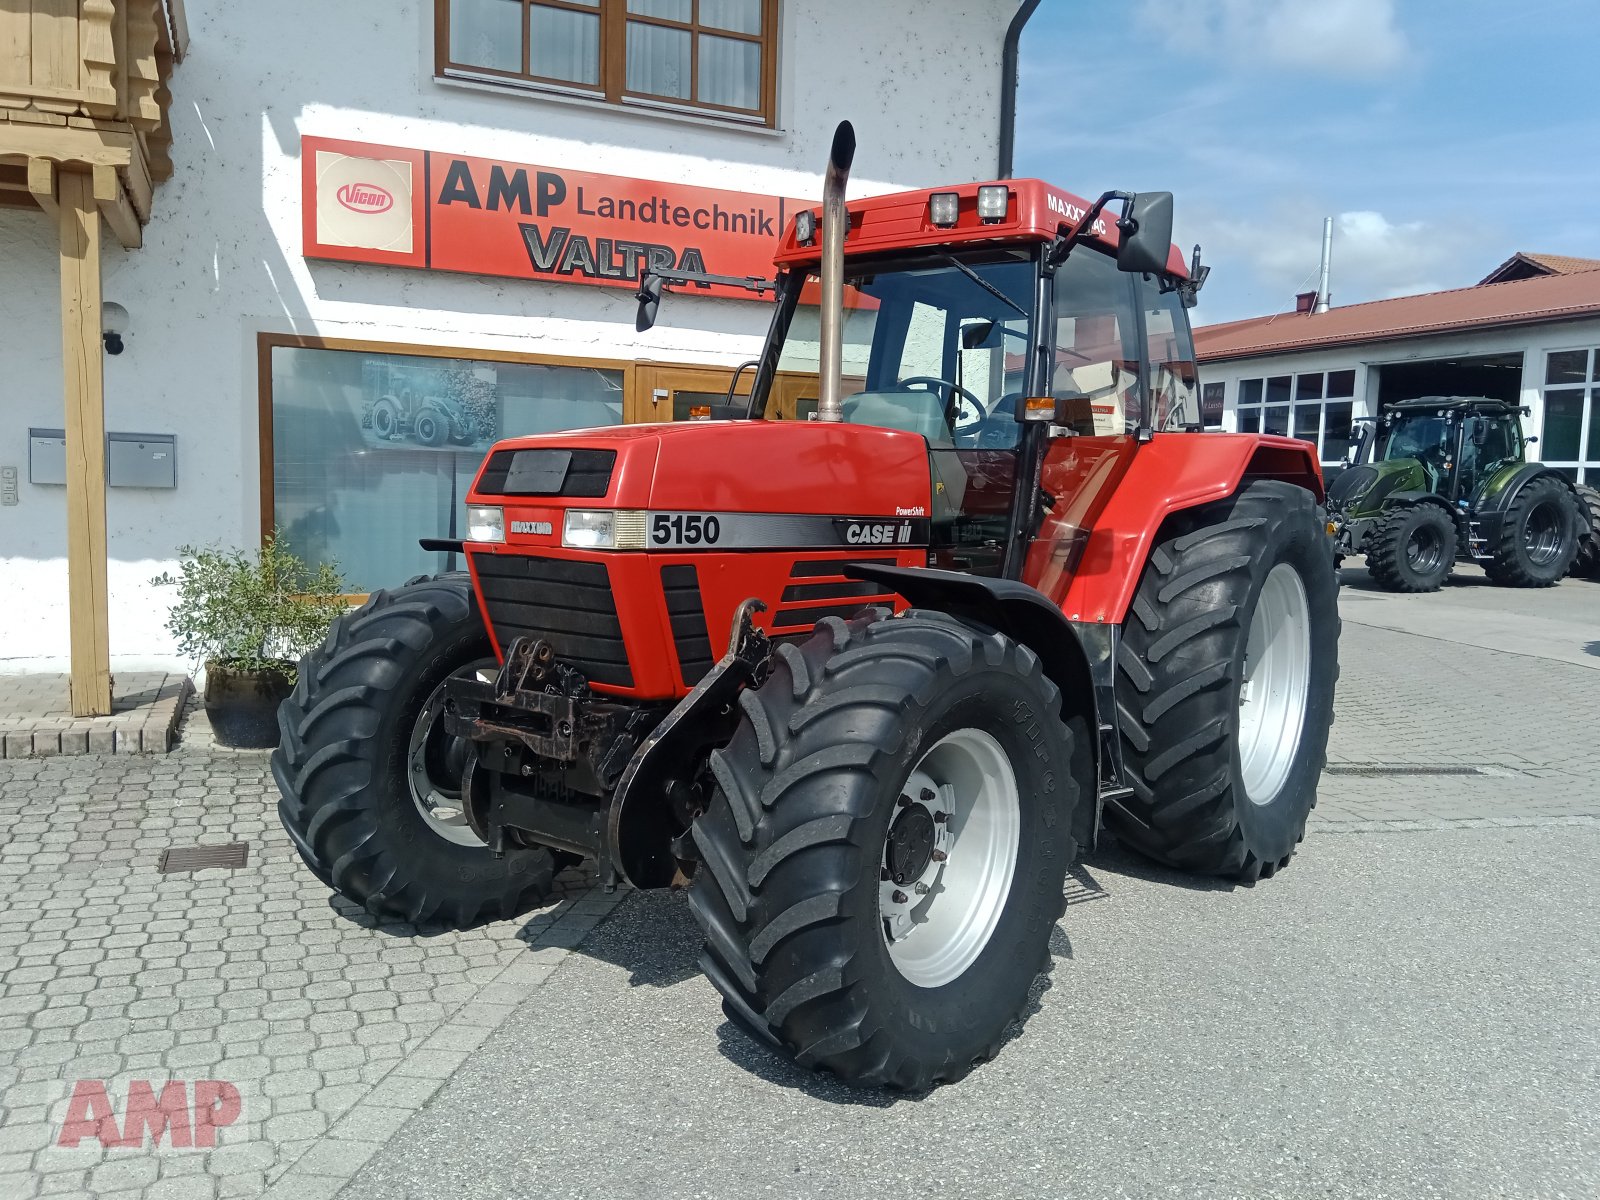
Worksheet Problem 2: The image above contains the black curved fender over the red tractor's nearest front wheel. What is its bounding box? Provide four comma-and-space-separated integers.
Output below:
843, 563, 1122, 846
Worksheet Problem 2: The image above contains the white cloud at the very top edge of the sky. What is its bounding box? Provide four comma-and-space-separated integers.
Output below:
1139, 0, 1411, 75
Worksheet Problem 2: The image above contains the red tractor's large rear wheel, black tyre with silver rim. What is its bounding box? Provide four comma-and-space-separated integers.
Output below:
1106, 480, 1339, 883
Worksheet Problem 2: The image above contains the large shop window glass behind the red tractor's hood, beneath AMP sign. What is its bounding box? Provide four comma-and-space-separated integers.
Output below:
261, 339, 622, 592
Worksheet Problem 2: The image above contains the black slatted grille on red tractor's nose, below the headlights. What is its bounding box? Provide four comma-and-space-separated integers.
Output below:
472, 554, 634, 688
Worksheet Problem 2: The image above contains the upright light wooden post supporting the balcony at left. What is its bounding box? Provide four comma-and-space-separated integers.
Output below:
59, 171, 110, 717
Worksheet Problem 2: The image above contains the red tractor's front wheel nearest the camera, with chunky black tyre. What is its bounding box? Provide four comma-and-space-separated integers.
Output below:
690, 610, 1093, 1091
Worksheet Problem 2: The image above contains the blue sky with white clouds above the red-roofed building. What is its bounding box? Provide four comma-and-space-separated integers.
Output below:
1016, 0, 1600, 323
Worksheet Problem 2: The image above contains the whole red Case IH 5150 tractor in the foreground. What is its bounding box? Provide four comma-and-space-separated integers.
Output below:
272, 125, 1339, 1090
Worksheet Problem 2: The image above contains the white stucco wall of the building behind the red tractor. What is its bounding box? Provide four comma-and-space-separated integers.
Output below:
0, 0, 1016, 670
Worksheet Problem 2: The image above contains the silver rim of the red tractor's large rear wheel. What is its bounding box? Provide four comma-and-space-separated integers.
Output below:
1238, 563, 1310, 805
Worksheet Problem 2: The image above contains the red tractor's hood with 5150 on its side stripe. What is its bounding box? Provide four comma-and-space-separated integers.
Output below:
467, 421, 931, 549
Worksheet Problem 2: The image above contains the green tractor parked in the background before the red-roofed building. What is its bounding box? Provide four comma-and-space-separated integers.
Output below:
1328, 395, 1597, 592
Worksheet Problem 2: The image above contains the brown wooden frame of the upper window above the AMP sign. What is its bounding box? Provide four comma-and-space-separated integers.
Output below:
434, 0, 782, 130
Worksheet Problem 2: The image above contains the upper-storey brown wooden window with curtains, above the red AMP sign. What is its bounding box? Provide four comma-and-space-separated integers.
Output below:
434, 0, 778, 125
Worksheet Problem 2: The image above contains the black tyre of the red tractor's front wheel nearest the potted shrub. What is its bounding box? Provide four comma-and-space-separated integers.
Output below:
272, 573, 555, 928
